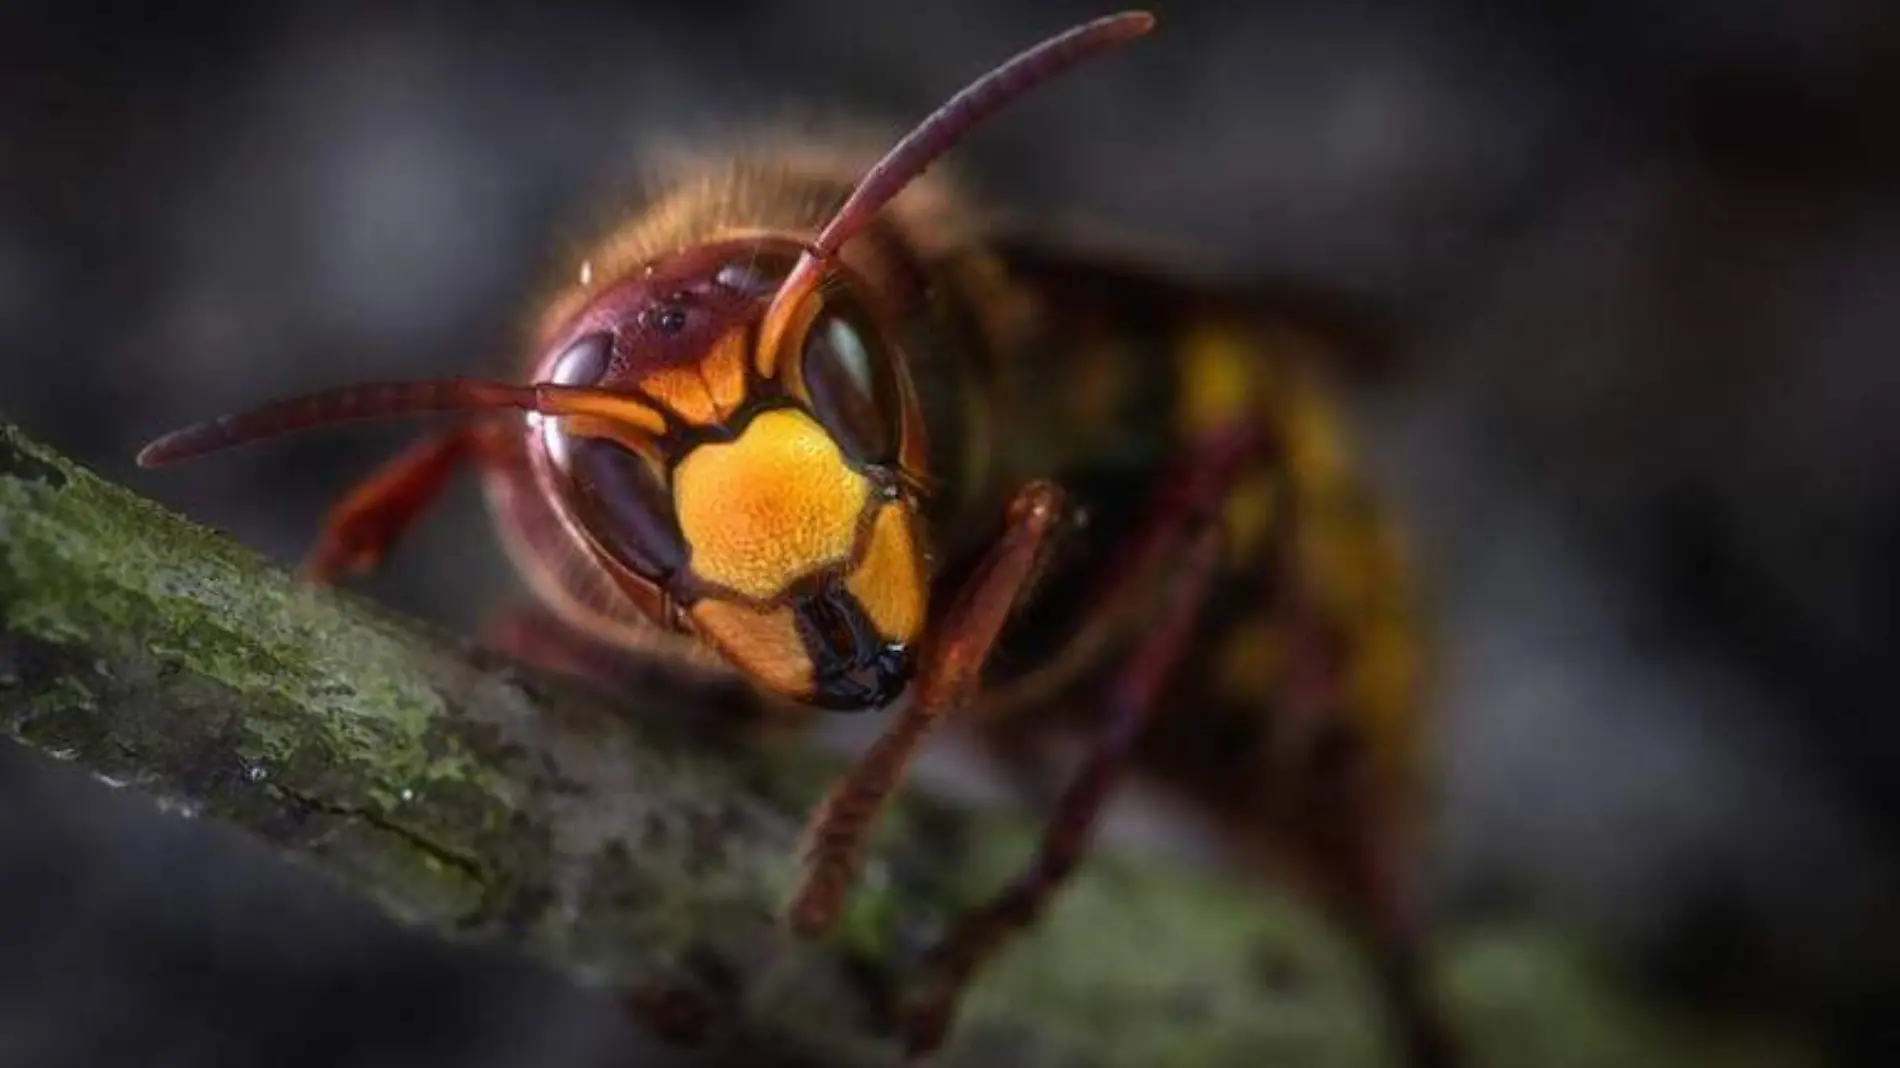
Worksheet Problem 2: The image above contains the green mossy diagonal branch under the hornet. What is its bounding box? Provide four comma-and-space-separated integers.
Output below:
0, 424, 1808, 1068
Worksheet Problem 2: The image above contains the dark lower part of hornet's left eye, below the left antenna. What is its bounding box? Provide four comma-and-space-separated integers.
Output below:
564, 437, 686, 582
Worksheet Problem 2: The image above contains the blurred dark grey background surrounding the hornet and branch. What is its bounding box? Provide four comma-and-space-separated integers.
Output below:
0, 0, 1900, 1064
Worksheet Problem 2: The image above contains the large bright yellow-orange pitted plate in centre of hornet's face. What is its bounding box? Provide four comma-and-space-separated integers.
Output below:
673, 409, 870, 601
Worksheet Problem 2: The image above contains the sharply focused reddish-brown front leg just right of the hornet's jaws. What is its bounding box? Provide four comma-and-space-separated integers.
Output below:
789, 483, 1062, 937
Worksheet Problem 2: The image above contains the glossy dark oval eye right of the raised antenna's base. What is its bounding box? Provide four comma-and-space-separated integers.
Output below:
800, 300, 899, 464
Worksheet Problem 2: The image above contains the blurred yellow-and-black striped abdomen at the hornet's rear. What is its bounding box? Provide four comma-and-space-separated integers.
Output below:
1174, 321, 1425, 805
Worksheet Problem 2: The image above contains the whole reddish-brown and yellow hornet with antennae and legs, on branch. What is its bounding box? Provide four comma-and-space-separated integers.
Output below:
141, 13, 1452, 1066
